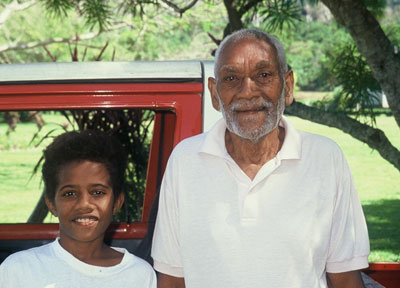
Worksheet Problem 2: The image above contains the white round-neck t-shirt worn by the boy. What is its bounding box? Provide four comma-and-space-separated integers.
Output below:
0, 240, 157, 288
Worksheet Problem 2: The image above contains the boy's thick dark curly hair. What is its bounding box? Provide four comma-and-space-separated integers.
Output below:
42, 130, 127, 201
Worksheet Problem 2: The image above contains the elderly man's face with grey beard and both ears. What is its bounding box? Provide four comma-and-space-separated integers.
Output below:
209, 38, 293, 142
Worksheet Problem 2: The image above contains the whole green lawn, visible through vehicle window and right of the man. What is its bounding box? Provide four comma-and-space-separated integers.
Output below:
0, 115, 400, 261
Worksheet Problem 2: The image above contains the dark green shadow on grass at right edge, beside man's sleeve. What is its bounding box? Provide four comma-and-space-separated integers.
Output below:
363, 199, 400, 262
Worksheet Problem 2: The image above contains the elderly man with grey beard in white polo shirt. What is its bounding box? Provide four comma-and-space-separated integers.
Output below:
152, 30, 369, 288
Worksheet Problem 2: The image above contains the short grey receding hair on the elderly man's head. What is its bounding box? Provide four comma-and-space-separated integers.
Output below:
214, 29, 288, 78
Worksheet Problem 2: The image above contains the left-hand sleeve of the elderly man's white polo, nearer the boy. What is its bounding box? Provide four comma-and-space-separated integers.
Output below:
151, 155, 183, 277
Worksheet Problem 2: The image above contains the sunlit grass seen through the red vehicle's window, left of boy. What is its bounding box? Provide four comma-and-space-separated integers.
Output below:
0, 114, 67, 223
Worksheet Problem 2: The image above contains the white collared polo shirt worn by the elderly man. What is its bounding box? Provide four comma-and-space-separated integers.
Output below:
152, 117, 369, 288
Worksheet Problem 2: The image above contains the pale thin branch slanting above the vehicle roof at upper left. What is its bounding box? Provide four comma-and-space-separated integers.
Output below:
0, 23, 128, 53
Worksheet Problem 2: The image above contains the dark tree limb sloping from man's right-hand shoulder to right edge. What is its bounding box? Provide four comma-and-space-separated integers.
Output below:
285, 102, 400, 171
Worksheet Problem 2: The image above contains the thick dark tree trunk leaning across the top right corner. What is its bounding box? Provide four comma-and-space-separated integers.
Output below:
321, 0, 400, 127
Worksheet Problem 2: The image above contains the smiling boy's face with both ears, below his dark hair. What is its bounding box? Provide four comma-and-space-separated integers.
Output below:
46, 161, 124, 246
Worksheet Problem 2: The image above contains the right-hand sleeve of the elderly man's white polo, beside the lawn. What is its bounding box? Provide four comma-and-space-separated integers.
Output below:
326, 152, 369, 273
